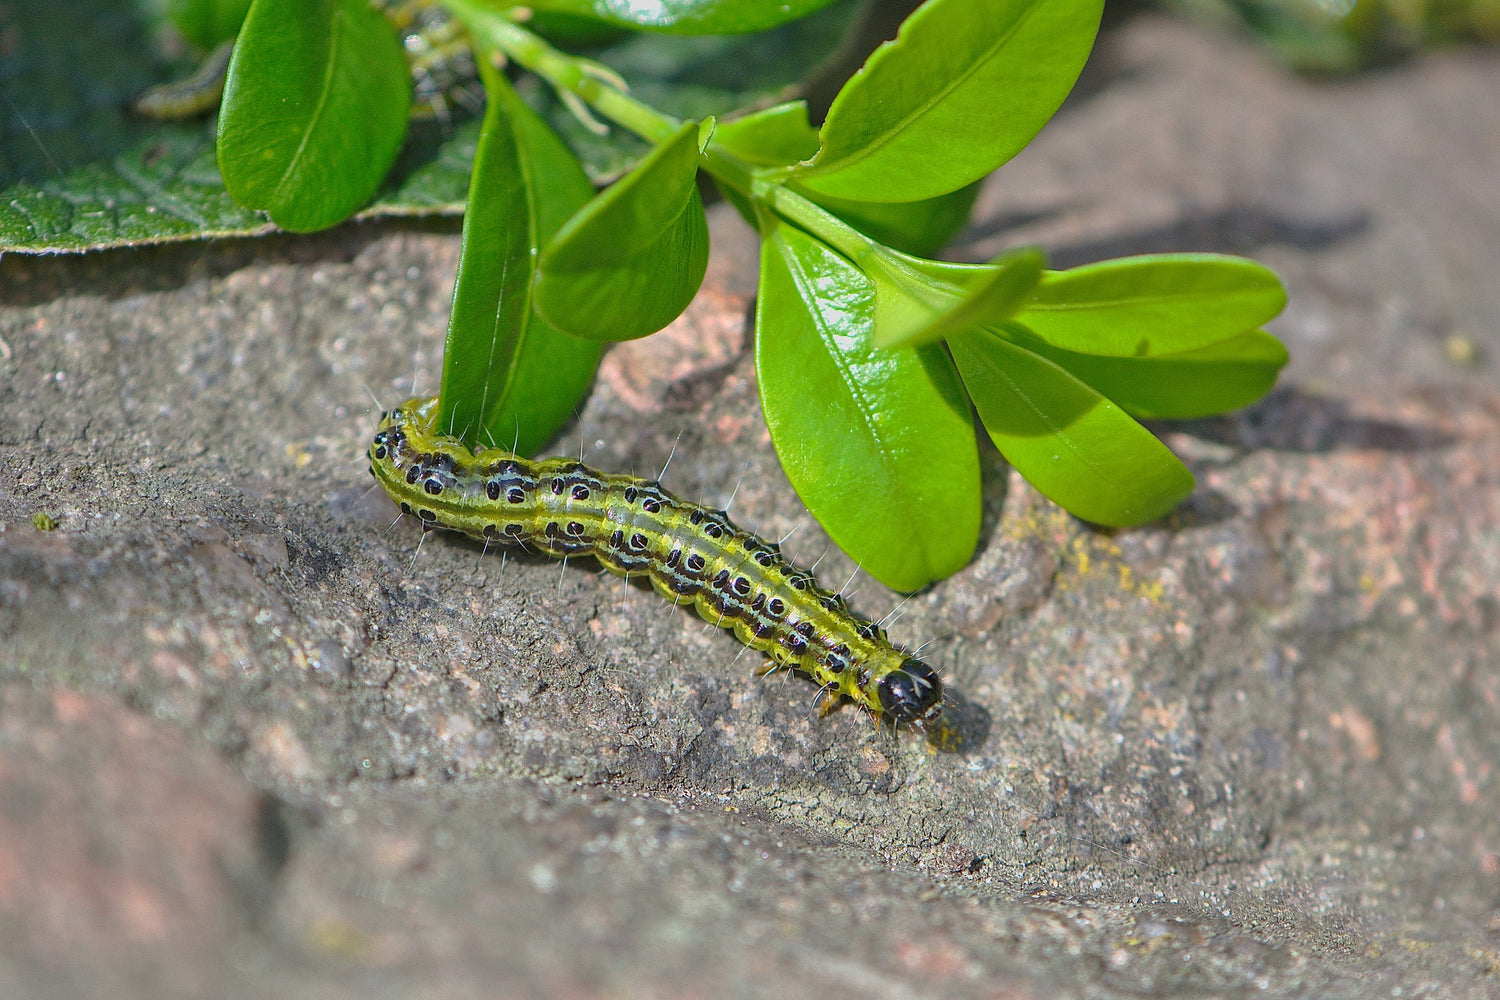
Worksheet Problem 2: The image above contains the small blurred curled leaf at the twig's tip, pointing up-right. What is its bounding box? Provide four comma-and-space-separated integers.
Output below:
872, 247, 1046, 348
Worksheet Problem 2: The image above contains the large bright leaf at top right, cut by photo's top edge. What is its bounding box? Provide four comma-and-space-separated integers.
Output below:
788, 0, 1103, 201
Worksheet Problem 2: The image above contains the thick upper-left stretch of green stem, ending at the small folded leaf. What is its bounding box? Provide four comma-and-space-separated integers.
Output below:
441, 0, 683, 144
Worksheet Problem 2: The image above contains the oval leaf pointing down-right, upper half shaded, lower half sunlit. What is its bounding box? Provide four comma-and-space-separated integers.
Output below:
948, 330, 1193, 526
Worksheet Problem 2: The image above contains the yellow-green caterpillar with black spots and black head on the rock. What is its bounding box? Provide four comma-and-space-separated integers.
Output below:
369, 397, 944, 729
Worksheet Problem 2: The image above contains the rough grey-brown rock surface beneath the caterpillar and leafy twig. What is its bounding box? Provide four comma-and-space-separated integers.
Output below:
0, 16, 1500, 1000
